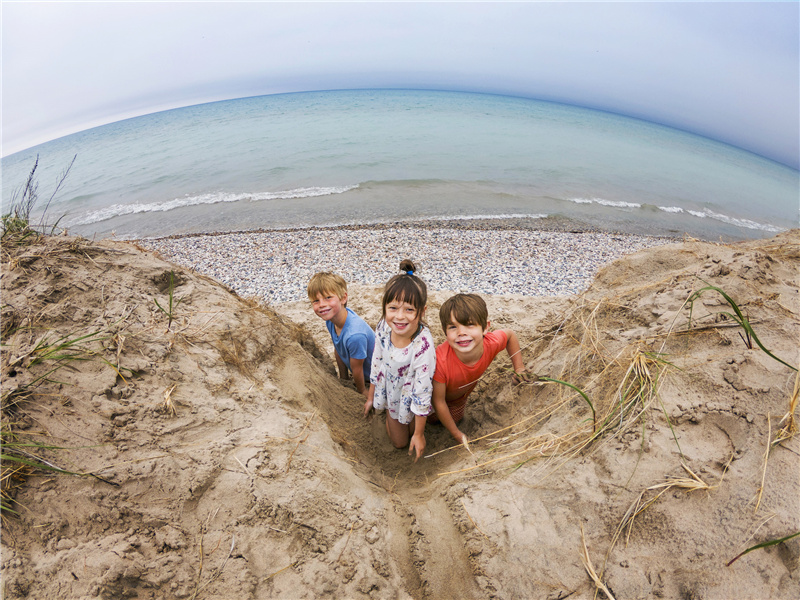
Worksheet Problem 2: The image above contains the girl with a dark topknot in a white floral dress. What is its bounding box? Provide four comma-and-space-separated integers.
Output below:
364, 260, 436, 462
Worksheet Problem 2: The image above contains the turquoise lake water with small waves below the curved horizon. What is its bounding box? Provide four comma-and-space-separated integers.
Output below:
2, 90, 800, 239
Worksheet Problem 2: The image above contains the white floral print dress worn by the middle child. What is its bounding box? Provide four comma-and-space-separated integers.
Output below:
370, 319, 436, 425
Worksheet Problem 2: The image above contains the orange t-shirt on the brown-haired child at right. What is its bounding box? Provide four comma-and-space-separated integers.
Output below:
428, 330, 508, 423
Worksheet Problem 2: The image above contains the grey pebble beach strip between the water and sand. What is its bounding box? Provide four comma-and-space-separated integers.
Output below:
137, 220, 676, 304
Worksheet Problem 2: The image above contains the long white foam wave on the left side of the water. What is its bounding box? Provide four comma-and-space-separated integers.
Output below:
68, 185, 358, 226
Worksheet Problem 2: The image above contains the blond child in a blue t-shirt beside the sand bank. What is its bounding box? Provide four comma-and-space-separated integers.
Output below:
308, 273, 375, 398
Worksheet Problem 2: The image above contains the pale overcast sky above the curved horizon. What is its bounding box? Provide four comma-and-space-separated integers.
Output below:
0, 0, 800, 168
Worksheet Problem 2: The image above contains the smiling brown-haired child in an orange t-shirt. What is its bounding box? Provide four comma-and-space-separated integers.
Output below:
431, 294, 525, 443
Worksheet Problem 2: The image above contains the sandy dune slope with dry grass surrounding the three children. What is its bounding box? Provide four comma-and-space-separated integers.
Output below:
2, 230, 800, 599
